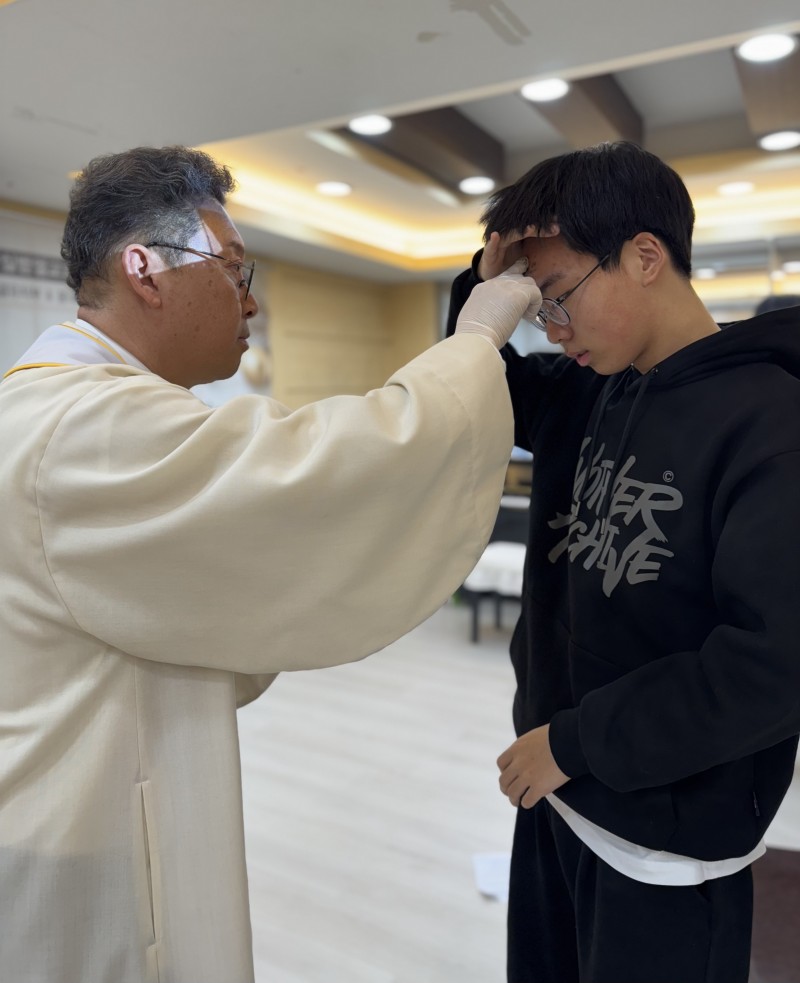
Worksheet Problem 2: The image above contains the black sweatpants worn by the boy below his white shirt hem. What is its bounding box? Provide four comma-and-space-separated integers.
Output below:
508, 800, 753, 983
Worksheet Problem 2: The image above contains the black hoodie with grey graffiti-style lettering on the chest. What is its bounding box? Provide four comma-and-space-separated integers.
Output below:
448, 258, 800, 860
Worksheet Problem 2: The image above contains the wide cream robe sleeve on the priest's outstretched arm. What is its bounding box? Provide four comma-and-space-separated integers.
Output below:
36, 336, 512, 672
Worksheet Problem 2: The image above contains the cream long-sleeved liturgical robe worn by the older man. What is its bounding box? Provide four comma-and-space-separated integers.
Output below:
0, 323, 512, 983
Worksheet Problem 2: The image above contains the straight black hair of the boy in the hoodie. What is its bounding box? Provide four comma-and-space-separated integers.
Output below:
481, 141, 694, 277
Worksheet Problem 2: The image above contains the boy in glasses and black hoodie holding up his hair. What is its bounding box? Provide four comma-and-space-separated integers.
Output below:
451, 143, 800, 983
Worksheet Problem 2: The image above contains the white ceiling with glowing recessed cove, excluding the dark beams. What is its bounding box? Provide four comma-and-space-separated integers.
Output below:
0, 0, 800, 281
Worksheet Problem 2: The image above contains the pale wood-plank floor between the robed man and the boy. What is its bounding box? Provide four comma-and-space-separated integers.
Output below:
239, 604, 516, 983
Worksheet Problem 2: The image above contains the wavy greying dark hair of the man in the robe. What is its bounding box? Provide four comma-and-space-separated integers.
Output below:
61, 146, 236, 306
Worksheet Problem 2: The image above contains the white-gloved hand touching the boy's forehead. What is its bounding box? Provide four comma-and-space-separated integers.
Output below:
456, 256, 542, 348
